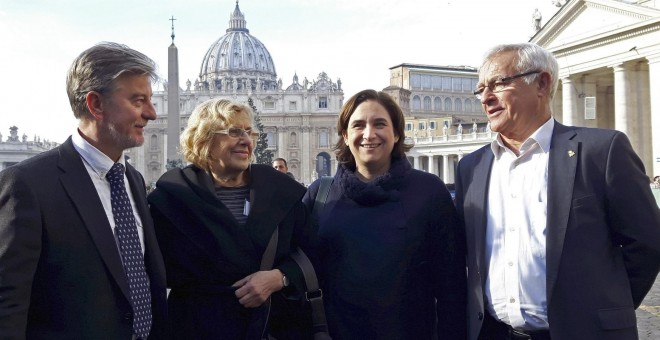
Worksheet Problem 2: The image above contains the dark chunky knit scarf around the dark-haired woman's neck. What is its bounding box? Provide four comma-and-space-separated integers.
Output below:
336, 157, 412, 207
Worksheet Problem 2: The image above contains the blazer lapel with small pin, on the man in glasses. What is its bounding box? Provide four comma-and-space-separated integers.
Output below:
546, 122, 581, 303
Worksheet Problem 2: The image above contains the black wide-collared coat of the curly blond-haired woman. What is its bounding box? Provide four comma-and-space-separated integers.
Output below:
148, 164, 308, 339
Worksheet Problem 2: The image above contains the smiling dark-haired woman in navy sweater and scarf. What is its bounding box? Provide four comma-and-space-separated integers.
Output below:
303, 90, 466, 340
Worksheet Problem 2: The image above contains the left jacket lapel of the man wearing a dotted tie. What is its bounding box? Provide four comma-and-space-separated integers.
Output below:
58, 138, 130, 299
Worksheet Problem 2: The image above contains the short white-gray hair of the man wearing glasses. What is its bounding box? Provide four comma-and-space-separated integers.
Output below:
479, 43, 559, 99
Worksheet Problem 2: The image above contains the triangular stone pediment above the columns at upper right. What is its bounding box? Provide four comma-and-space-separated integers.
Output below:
530, 0, 660, 50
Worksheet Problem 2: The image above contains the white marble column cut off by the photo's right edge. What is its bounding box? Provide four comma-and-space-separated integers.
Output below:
646, 54, 660, 176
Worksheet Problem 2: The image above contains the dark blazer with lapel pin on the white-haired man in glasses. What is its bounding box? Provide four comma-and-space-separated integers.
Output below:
456, 123, 660, 340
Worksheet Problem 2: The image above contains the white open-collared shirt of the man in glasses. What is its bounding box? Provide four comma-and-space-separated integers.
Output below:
485, 118, 555, 330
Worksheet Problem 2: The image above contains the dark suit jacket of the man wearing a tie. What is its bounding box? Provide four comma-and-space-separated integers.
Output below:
0, 138, 166, 340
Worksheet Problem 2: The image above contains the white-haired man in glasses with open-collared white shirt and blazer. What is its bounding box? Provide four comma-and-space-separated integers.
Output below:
456, 43, 660, 340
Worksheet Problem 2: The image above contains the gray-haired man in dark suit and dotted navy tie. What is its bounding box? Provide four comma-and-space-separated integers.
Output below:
0, 43, 166, 340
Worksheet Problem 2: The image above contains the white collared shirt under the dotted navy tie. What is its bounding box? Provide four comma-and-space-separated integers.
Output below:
71, 129, 144, 254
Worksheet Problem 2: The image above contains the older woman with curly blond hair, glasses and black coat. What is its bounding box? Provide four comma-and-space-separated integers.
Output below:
148, 99, 314, 339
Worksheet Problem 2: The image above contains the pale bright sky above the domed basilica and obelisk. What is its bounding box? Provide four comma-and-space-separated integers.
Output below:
0, 0, 557, 142
